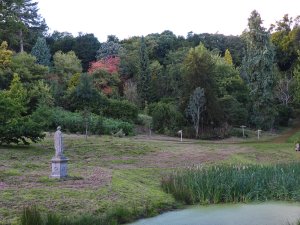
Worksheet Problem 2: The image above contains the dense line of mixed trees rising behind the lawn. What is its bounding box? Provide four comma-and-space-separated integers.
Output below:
0, 0, 300, 143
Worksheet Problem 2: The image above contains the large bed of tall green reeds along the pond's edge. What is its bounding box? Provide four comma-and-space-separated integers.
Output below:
162, 163, 300, 204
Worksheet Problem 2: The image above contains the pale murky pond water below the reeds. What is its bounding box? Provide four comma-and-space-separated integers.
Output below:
130, 202, 300, 225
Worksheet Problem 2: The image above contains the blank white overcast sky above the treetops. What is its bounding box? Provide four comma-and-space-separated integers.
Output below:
37, 0, 300, 42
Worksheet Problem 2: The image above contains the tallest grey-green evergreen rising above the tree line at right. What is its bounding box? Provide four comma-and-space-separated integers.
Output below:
243, 11, 276, 129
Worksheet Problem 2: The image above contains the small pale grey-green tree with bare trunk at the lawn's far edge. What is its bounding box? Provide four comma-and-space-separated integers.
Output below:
186, 87, 206, 138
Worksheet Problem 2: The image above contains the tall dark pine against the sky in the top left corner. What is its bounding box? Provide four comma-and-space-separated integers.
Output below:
0, 0, 47, 52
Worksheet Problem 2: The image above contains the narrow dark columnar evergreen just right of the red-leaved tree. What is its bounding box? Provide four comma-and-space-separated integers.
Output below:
138, 37, 151, 104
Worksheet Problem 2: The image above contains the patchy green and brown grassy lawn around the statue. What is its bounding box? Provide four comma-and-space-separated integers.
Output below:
0, 132, 300, 224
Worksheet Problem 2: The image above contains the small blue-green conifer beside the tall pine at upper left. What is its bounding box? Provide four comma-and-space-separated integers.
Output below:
31, 38, 51, 66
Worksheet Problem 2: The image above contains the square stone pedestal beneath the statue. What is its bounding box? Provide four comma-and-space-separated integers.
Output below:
50, 156, 69, 178
